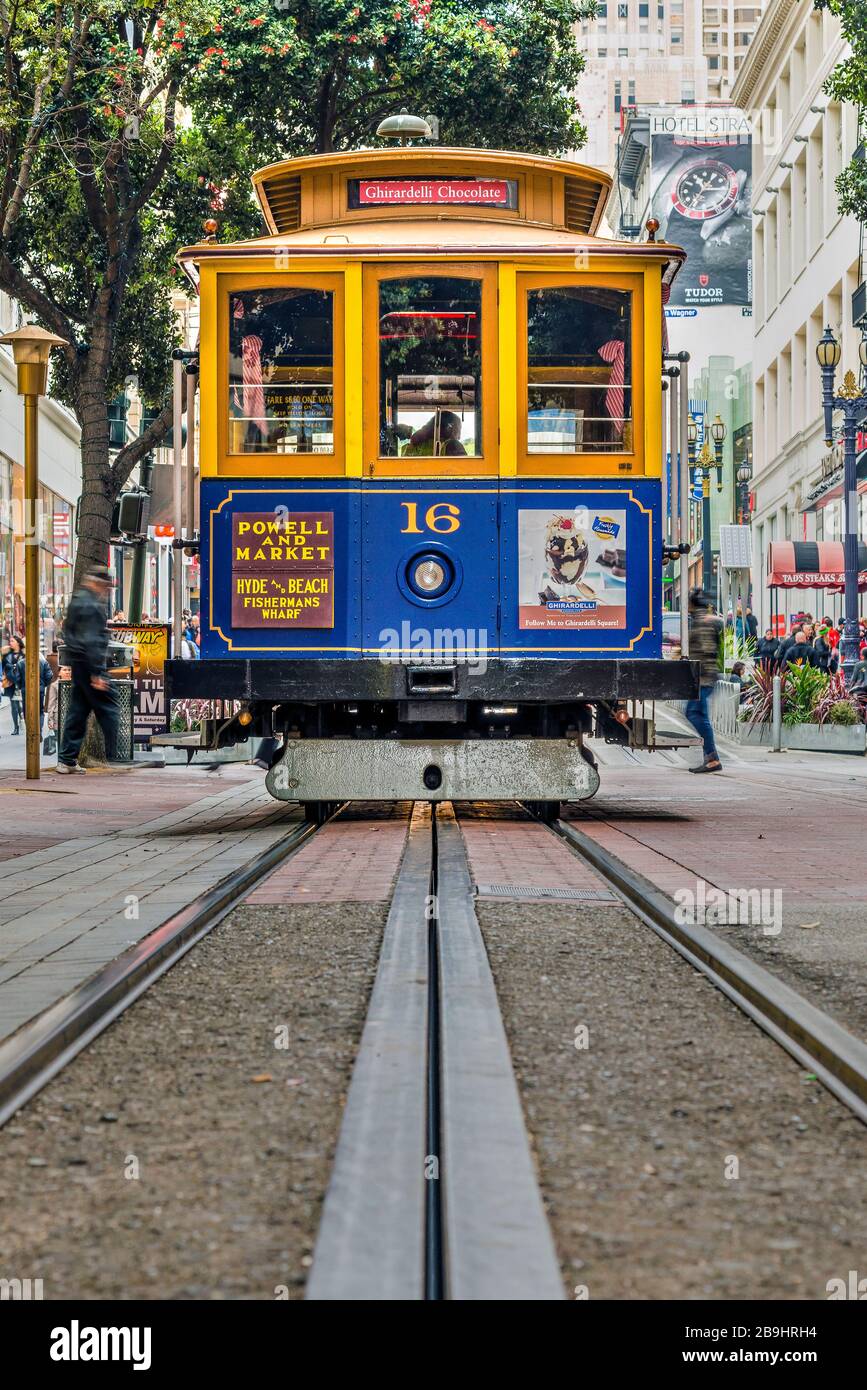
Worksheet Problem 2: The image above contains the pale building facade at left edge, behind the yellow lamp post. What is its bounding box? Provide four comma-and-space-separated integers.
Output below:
0, 293, 81, 651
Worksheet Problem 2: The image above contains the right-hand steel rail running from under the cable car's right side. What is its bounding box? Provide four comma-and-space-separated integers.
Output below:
546, 820, 867, 1123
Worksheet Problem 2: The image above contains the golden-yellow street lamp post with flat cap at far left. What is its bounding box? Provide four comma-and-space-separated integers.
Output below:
0, 324, 65, 781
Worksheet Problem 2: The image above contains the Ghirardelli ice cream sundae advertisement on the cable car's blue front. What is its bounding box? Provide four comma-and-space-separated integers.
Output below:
518, 507, 627, 630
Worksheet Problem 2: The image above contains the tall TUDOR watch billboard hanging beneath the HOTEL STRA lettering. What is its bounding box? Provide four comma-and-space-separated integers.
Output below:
650, 106, 753, 308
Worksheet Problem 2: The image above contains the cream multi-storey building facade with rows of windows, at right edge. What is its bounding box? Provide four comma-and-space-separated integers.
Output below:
732, 0, 867, 626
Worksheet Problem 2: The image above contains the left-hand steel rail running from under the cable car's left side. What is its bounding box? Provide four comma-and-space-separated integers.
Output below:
0, 821, 332, 1126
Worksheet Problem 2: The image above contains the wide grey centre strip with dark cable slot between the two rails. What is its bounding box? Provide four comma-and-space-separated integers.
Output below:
306, 802, 564, 1301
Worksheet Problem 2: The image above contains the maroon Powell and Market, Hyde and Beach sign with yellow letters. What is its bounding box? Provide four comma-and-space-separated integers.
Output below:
232, 509, 333, 628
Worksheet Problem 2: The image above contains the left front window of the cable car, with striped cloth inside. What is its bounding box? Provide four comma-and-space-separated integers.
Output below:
229, 288, 333, 453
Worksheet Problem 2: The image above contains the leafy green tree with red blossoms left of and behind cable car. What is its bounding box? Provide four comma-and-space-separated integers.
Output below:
0, 0, 593, 573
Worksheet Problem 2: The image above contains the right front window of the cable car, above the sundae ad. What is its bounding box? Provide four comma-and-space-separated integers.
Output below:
527, 285, 632, 455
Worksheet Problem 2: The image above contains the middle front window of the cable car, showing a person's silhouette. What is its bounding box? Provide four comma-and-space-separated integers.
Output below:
379, 275, 482, 459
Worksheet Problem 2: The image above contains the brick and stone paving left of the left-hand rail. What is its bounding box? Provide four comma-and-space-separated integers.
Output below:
0, 766, 300, 1038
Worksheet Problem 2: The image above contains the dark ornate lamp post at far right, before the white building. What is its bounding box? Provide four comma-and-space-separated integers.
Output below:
816, 327, 867, 680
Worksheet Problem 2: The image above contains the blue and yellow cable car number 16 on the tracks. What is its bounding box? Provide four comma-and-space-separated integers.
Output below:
167, 118, 695, 815
